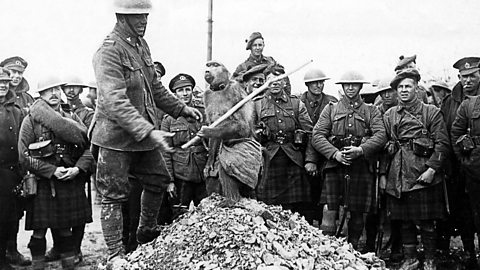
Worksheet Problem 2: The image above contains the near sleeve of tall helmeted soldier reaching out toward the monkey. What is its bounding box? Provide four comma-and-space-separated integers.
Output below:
93, 44, 154, 141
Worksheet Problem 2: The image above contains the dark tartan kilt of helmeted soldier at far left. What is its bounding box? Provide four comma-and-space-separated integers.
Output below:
25, 176, 93, 230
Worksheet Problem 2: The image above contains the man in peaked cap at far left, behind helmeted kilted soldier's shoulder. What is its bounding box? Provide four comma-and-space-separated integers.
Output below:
0, 56, 34, 112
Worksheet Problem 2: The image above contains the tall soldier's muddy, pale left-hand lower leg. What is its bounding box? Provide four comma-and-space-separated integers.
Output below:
100, 203, 125, 260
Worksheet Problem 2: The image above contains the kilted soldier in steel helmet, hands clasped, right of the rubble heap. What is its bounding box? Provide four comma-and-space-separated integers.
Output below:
312, 71, 386, 249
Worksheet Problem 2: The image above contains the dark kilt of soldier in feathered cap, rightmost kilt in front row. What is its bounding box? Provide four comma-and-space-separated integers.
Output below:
387, 183, 446, 220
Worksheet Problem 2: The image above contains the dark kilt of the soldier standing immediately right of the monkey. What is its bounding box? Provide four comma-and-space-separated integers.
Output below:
256, 149, 311, 204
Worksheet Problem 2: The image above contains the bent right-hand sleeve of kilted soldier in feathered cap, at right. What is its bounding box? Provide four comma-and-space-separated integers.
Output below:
425, 108, 450, 171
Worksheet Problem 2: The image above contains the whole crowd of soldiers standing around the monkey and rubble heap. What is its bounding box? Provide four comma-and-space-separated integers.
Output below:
0, 0, 480, 270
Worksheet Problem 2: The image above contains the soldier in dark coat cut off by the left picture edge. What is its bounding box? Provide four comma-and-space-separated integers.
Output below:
0, 68, 24, 270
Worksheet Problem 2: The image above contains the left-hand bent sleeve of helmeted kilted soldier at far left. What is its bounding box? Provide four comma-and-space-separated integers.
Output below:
18, 116, 57, 179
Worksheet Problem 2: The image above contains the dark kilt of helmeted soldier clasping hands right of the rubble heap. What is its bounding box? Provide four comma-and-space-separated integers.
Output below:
320, 160, 375, 213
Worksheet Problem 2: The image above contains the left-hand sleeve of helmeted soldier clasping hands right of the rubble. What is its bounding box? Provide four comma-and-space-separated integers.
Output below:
312, 104, 339, 160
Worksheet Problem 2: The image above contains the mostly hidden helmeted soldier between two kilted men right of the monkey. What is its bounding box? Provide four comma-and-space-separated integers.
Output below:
300, 69, 338, 224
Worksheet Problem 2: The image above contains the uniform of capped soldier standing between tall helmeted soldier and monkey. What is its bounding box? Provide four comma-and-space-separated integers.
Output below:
162, 108, 207, 206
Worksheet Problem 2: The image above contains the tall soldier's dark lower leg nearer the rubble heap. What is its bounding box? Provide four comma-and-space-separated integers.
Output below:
137, 189, 163, 244
